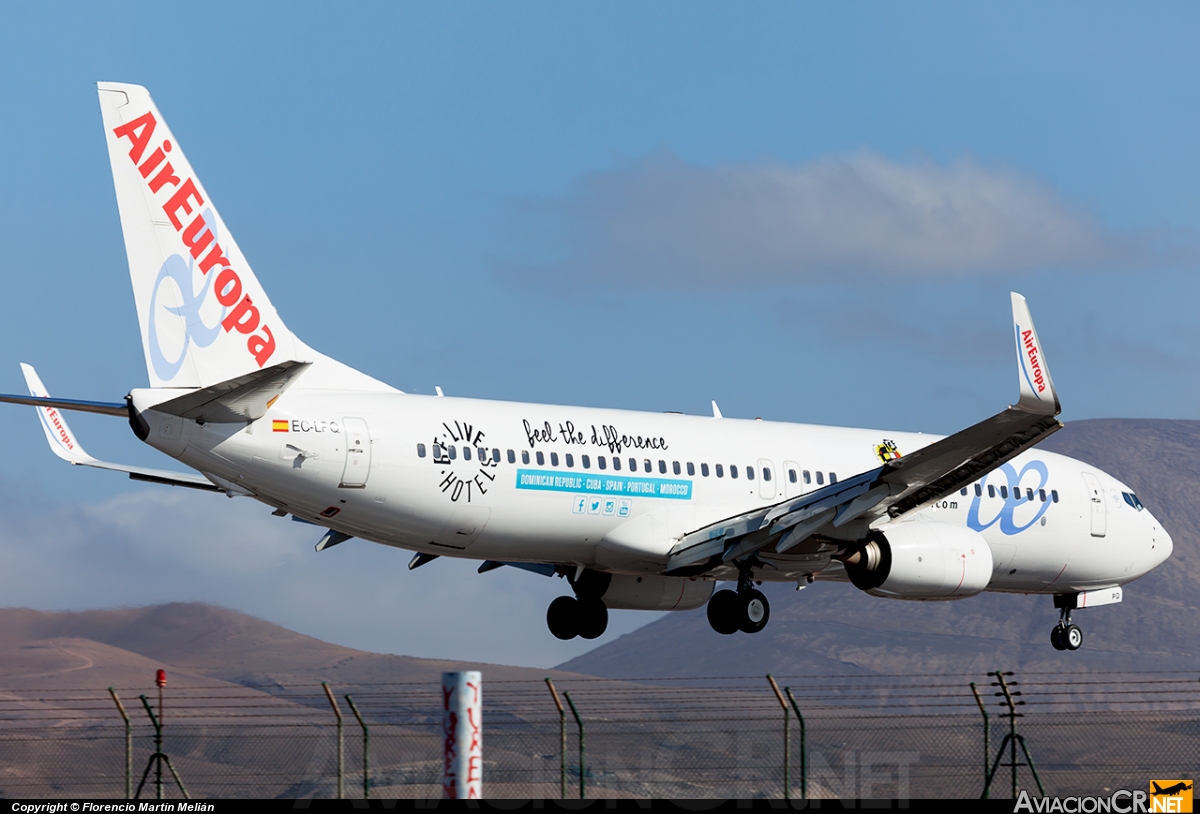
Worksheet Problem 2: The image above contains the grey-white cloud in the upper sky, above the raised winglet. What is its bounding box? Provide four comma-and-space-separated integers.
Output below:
505, 151, 1163, 286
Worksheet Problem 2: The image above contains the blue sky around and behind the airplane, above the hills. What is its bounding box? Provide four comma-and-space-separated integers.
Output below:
0, 2, 1200, 664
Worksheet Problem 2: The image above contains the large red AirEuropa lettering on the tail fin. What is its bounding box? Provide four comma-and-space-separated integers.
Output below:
113, 113, 275, 367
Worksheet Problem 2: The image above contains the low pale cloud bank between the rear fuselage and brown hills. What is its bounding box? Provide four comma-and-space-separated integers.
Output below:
0, 487, 658, 666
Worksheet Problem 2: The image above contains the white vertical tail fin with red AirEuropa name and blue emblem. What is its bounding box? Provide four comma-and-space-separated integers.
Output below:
98, 82, 298, 388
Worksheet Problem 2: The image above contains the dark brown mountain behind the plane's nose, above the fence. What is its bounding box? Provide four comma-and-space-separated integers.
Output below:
559, 419, 1200, 677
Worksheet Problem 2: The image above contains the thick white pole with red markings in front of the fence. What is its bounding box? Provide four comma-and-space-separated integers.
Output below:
442, 670, 484, 800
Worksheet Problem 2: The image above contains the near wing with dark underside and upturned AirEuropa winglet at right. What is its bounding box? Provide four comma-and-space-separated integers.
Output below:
666, 293, 1062, 575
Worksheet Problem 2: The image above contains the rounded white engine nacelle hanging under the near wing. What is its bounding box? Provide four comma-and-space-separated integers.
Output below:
844, 520, 992, 599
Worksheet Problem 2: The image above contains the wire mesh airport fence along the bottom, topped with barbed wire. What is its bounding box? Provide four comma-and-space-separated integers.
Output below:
0, 672, 1200, 800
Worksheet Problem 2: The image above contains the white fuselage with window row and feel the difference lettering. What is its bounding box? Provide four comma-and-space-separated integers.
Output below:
133, 384, 1171, 593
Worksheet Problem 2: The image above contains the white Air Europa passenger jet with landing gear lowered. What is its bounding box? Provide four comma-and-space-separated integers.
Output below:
0, 82, 1172, 651
